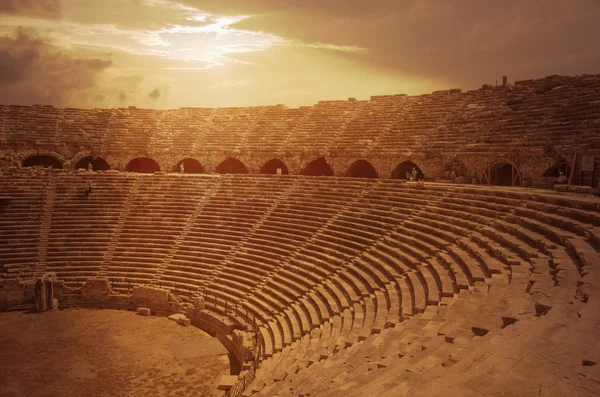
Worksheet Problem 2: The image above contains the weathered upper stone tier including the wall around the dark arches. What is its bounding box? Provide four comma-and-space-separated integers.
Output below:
0, 75, 600, 183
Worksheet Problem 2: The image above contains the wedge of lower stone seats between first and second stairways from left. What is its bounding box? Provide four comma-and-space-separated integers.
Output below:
46, 173, 136, 288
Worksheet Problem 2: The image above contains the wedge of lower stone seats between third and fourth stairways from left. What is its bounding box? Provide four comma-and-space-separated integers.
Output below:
158, 176, 292, 300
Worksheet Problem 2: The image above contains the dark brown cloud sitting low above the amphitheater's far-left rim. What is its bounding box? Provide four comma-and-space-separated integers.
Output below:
0, 29, 111, 107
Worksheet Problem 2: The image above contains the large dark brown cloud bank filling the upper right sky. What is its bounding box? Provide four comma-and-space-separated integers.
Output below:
187, 0, 600, 88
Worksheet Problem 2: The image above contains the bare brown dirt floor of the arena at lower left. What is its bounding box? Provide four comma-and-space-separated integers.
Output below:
0, 309, 229, 397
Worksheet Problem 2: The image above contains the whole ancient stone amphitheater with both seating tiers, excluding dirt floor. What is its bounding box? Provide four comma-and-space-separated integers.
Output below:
0, 75, 600, 397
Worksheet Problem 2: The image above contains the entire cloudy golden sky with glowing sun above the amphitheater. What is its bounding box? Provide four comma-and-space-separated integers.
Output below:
0, 0, 600, 109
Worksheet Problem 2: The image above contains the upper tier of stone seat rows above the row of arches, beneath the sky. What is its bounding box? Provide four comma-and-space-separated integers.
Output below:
0, 75, 600, 154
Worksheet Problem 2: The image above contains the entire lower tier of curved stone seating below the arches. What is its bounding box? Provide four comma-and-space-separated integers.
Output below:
0, 171, 600, 396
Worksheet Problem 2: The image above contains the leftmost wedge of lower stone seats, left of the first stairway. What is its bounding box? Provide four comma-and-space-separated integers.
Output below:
0, 173, 49, 278
